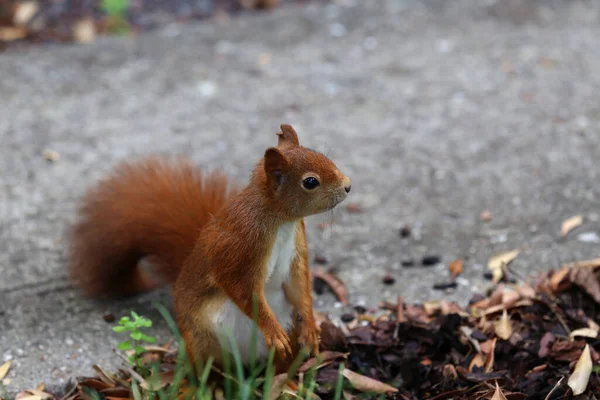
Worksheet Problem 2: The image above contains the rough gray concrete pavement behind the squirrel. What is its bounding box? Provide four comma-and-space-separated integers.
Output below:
0, 0, 600, 389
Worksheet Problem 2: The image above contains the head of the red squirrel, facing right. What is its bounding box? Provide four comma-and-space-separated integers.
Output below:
254, 125, 352, 218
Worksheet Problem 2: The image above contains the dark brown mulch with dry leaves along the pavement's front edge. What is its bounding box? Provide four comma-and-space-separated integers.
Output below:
9, 259, 600, 400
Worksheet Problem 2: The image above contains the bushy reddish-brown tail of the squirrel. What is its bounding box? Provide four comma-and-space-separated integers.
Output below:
69, 157, 237, 296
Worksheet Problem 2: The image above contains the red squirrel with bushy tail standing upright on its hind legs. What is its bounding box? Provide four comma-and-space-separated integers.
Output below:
68, 125, 351, 368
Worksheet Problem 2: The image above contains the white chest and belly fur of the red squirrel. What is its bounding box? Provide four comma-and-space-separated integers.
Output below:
213, 223, 297, 363
